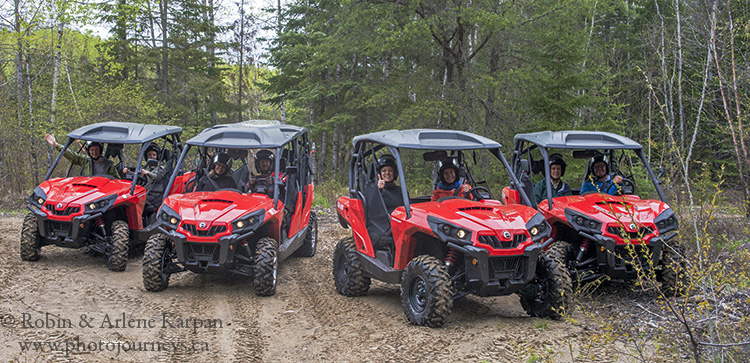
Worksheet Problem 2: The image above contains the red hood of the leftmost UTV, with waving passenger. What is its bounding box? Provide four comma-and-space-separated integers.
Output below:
39, 176, 137, 210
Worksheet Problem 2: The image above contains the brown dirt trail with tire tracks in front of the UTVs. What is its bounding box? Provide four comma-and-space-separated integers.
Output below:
0, 212, 640, 362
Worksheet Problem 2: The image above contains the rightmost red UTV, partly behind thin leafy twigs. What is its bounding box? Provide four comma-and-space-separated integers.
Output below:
503, 131, 685, 295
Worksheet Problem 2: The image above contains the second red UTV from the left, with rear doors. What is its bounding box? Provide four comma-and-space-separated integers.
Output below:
143, 121, 317, 295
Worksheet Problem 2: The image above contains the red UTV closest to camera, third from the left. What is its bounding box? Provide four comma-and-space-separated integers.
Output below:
333, 129, 571, 327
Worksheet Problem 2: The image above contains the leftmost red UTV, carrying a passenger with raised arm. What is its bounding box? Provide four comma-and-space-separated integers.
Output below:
21, 122, 182, 271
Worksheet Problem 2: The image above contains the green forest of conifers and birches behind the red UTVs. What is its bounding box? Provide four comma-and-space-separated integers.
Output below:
0, 0, 750, 213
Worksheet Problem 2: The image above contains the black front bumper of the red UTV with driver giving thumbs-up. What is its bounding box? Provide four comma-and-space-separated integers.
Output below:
448, 243, 542, 296
